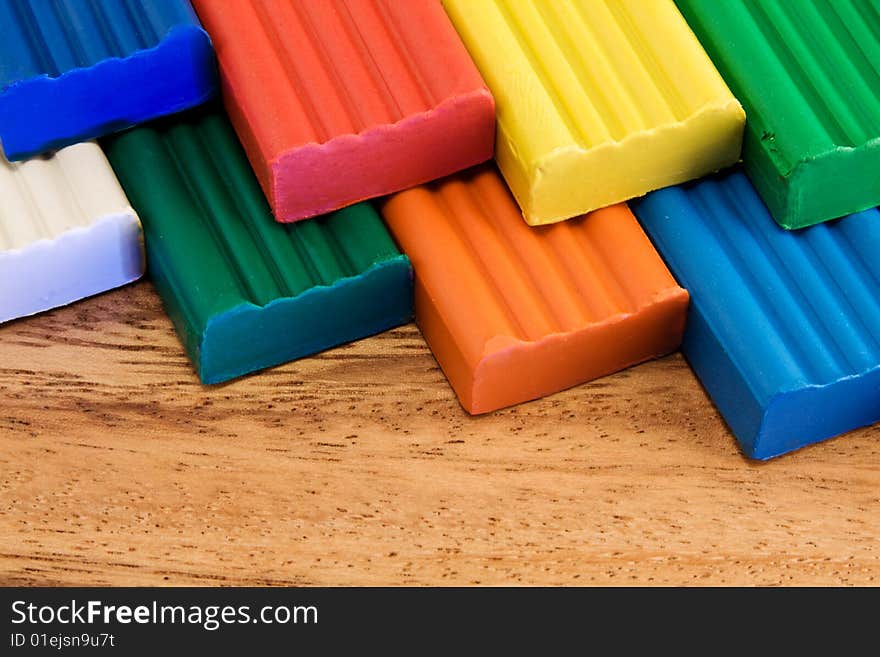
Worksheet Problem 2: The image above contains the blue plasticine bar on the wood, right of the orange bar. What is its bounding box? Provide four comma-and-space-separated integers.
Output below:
633, 169, 880, 459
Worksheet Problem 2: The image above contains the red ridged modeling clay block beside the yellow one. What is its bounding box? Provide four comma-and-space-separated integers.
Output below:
194, 0, 495, 221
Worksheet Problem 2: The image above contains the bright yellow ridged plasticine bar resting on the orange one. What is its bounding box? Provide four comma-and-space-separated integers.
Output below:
443, 0, 745, 225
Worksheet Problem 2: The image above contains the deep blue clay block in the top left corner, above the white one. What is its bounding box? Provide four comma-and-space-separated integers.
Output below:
0, 0, 217, 160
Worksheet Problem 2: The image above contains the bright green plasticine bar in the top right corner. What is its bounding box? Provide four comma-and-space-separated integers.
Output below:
677, 0, 880, 228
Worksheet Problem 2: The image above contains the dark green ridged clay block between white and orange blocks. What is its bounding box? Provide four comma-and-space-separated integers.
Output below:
107, 107, 412, 383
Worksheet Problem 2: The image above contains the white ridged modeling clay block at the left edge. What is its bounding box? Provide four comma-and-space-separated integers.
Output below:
0, 143, 144, 322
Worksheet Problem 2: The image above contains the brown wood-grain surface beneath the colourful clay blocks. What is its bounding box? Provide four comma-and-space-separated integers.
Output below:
0, 283, 880, 585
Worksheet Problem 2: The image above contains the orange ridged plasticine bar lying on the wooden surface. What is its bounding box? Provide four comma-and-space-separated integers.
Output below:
382, 166, 688, 413
